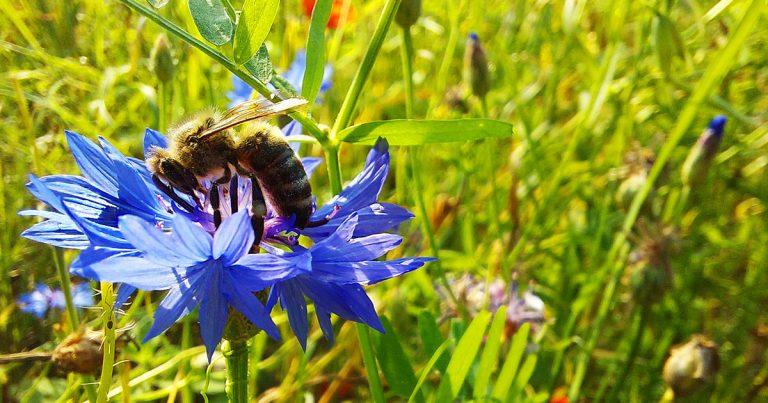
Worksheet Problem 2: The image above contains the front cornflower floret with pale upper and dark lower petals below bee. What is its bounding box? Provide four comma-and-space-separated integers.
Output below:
72, 210, 311, 358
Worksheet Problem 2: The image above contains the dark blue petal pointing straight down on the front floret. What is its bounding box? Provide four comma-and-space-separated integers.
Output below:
198, 267, 229, 362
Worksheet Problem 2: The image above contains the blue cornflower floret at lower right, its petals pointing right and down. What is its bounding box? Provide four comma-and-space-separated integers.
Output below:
267, 214, 435, 348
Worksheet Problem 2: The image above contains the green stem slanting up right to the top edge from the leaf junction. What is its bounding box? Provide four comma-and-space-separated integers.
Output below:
328, 0, 400, 137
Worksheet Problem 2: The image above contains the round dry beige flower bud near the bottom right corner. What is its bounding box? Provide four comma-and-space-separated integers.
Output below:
664, 335, 719, 396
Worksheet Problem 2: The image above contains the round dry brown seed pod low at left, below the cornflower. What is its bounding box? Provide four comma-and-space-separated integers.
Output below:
51, 331, 103, 374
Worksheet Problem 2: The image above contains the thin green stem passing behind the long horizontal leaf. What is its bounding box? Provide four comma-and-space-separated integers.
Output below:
399, 27, 466, 315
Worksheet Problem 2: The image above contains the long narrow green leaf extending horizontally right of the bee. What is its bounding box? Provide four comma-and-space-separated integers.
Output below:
339, 119, 513, 146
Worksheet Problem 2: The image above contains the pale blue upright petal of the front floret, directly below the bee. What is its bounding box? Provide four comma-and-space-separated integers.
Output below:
213, 210, 256, 266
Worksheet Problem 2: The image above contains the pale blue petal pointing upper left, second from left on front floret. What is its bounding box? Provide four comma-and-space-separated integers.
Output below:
120, 215, 210, 267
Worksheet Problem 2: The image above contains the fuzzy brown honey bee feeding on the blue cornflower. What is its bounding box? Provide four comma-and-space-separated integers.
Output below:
147, 98, 312, 245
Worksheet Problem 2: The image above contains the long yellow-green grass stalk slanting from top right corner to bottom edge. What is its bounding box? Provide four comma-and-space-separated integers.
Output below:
568, 0, 764, 402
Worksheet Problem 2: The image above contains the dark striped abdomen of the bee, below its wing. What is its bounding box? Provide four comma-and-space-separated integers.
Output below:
236, 123, 312, 228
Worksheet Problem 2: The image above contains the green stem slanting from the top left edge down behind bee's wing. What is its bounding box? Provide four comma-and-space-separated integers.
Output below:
119, 0, 326, 141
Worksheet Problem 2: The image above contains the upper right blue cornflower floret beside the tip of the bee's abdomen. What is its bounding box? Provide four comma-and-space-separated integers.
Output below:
301, 139, 413, 242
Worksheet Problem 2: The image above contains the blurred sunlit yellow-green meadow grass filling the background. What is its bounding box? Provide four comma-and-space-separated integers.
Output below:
0, 0, 768, 402
